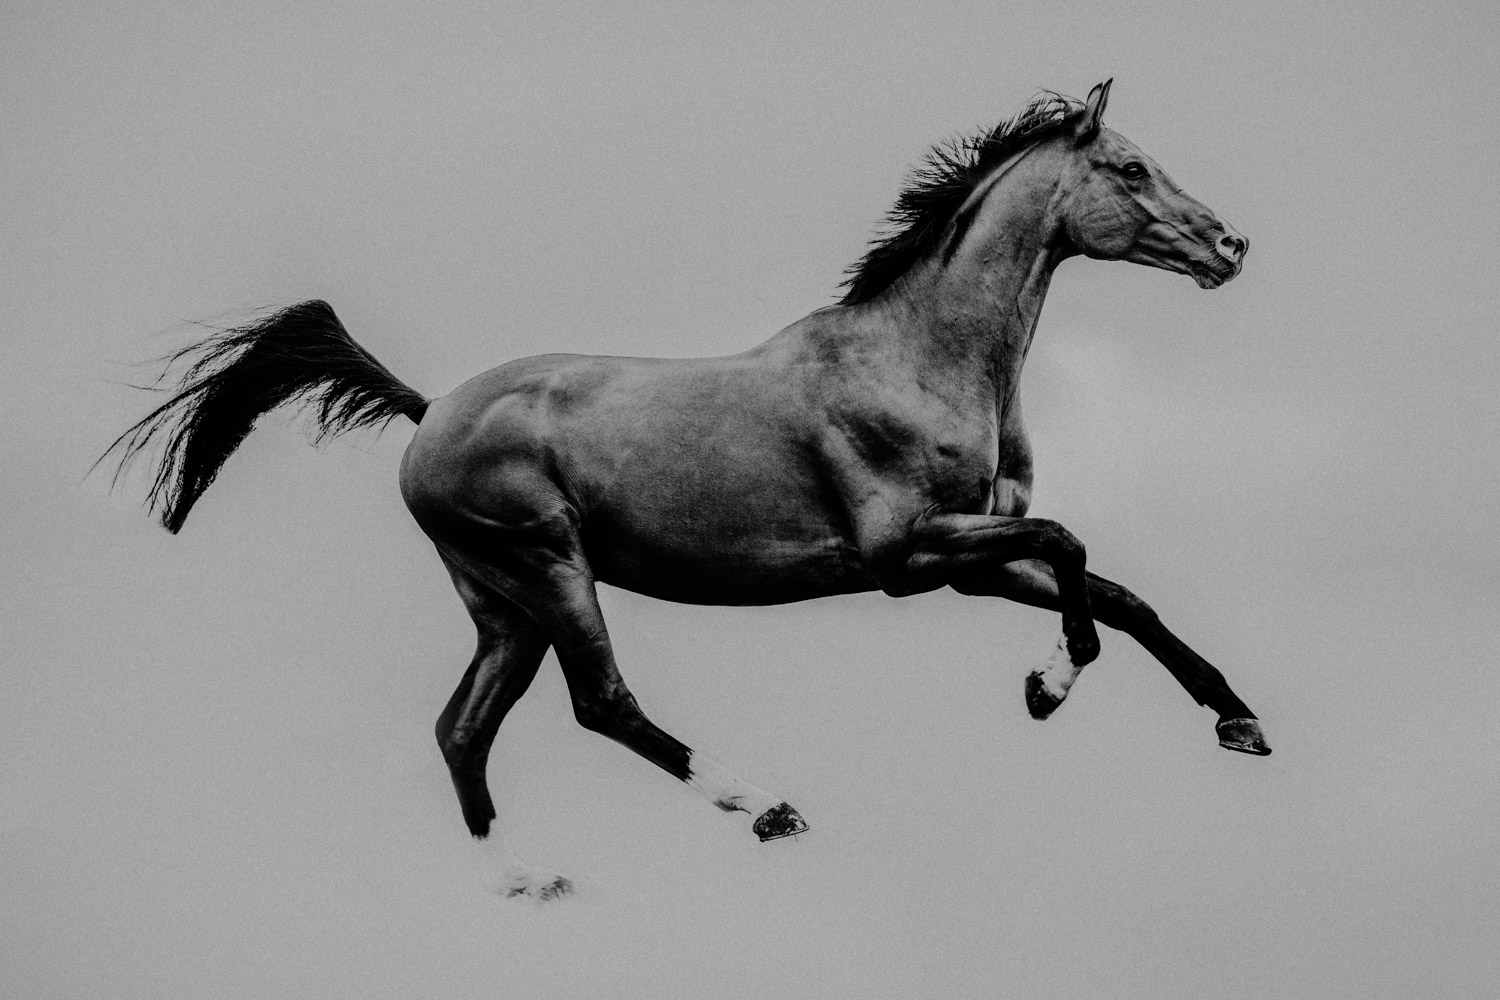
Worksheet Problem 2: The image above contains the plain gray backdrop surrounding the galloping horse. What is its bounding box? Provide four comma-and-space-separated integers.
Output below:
0, 0, 1500, 1000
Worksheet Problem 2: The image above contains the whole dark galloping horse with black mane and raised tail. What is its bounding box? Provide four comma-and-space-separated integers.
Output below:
105, 82, 1271, 898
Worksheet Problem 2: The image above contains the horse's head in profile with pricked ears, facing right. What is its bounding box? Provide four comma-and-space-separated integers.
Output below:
1056, 82, 1250, 288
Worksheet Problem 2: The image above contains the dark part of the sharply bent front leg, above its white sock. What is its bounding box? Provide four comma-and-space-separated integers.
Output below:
902, 513, 1100, 669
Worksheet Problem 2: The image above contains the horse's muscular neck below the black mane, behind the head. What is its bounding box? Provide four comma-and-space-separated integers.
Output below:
873, 162, 1065, 411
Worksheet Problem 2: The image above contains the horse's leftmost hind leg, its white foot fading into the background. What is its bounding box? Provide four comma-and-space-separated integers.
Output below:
437, 559, 573, 900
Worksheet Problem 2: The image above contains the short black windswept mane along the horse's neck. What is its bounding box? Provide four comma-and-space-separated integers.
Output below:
840, 90, 1083, 306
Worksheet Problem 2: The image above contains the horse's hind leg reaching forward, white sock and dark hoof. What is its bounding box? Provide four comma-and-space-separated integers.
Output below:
456, 525, 807, 841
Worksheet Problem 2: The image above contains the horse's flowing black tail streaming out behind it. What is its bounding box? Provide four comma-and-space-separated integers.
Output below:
96, 300, 428, 534
